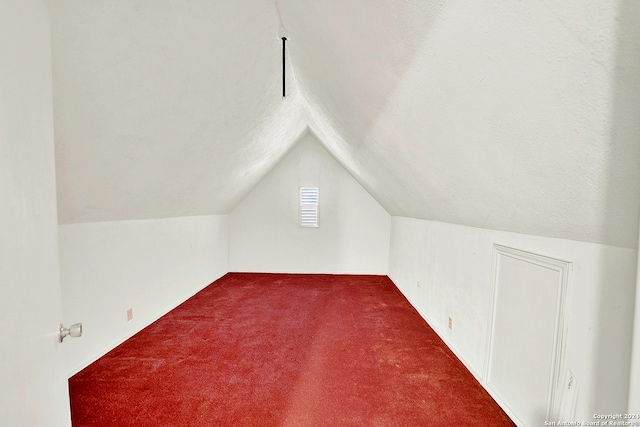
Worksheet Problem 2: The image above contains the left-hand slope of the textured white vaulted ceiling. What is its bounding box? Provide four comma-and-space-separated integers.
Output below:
49, 0, 305, 223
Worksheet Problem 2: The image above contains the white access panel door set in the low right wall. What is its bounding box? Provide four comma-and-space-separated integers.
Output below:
486, 245, 568, 426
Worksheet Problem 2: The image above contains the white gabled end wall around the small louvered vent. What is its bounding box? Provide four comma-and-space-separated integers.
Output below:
229, 134, 391, 274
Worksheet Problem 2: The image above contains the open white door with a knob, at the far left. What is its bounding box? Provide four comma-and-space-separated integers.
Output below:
0, 0, 71, 427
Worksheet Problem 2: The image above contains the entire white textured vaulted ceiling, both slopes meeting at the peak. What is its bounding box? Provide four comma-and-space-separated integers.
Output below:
49, 0, 640, 247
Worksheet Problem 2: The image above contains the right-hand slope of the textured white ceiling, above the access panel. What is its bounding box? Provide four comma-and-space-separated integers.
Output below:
277, 0, 640, 247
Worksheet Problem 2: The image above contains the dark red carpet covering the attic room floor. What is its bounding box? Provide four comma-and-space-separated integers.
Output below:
69, 273, 514, 427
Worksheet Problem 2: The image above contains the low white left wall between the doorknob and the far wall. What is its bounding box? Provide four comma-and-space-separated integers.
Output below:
59, 216, 228, 375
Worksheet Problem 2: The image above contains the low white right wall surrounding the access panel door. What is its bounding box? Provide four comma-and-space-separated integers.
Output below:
389, 217, 637, 420
